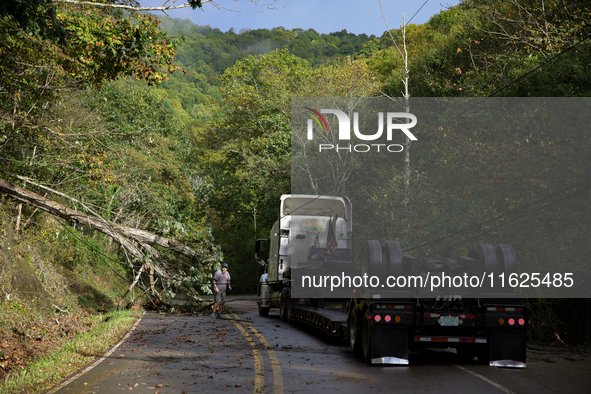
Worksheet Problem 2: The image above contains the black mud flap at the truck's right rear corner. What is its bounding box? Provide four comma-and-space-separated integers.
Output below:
487, 330, 526, 368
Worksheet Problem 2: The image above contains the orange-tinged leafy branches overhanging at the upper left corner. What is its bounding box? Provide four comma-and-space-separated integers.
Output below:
0, 2, 184, 118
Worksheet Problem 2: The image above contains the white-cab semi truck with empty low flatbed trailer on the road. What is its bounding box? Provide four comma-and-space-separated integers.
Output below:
255, 194, 528, 368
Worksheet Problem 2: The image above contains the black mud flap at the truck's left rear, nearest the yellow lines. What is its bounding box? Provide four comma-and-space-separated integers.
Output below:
371, 325, 408, 365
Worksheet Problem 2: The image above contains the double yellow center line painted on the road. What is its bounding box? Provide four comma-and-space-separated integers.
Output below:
225, 314, 283, 394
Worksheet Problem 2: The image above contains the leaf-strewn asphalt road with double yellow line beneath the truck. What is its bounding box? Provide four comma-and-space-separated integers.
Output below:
45, 297, 591, 394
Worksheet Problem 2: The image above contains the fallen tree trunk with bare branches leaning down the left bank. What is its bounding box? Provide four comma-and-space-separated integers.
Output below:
0, 171, 217, 302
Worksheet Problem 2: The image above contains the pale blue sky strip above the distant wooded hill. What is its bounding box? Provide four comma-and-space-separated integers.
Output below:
140, 0, 460, 37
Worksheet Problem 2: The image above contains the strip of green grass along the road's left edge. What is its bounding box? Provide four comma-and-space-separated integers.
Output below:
0, 310, 142, 394
